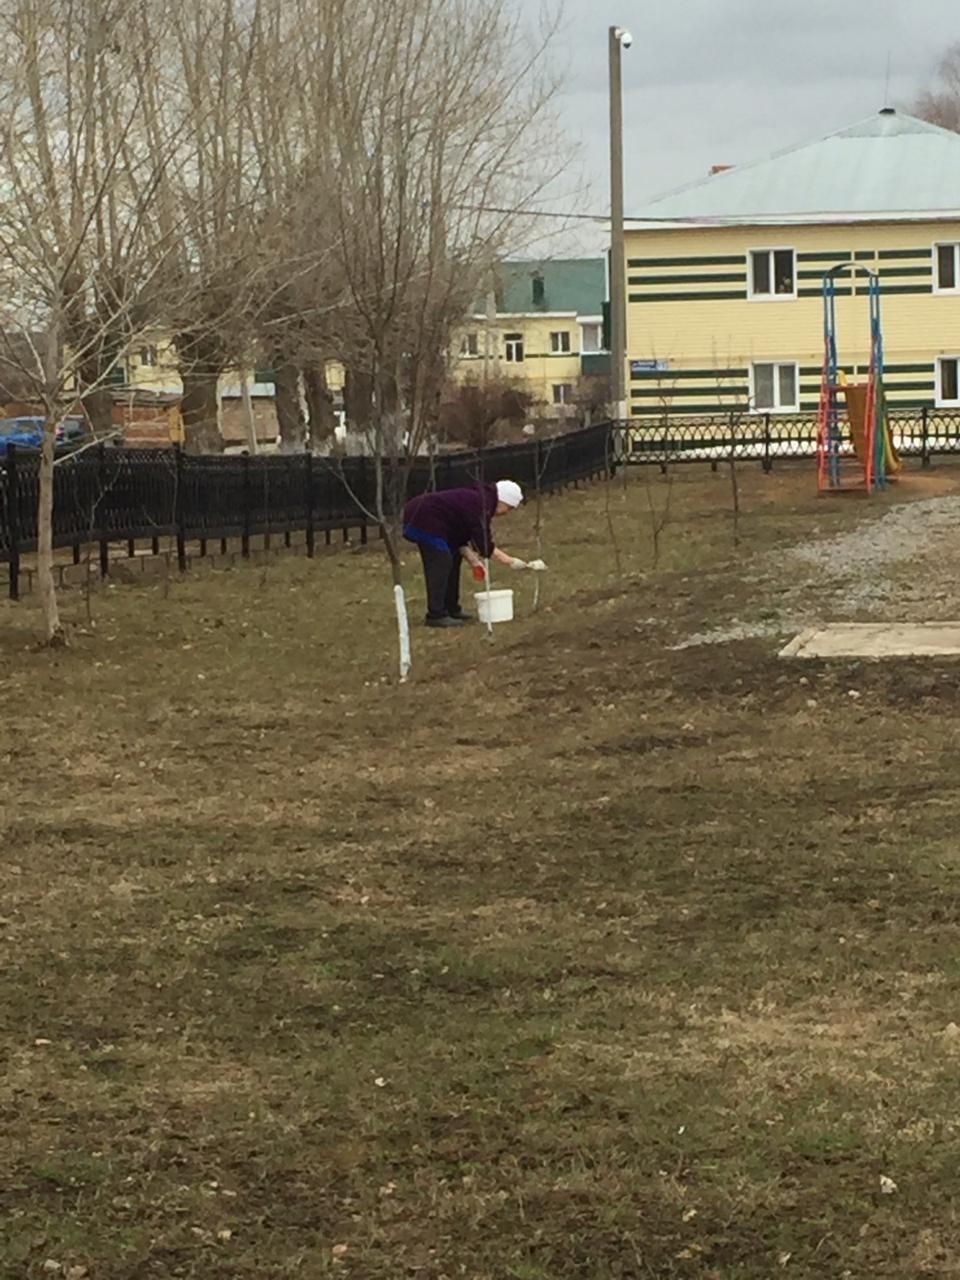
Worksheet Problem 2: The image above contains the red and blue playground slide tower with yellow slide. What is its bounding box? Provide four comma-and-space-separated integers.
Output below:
817, 262, 900, 493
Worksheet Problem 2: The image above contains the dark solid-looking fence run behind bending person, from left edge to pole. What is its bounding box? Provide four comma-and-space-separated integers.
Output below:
0, 422, 613, 599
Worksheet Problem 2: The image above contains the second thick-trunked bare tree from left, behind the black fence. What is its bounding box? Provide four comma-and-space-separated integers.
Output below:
148, 0, 312, 452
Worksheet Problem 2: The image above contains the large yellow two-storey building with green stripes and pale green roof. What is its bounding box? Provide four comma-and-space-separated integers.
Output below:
625, 108, 960, 416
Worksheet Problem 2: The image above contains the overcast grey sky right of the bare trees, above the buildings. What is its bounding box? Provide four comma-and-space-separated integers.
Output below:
535, 0, 960, 252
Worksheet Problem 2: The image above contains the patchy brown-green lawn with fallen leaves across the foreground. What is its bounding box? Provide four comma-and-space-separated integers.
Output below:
0, 468, 960, 1280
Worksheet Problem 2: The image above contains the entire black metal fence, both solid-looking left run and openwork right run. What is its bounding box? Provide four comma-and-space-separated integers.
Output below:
9, 408, 960, 599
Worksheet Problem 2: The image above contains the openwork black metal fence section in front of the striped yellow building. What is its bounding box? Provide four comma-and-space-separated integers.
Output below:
627, 408, 960, 470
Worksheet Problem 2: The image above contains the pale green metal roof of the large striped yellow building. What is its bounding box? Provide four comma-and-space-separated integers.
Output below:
628, 108, 960, 227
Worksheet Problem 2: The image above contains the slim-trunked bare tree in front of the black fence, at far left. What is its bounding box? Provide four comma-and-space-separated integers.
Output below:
0, 0, 217, 644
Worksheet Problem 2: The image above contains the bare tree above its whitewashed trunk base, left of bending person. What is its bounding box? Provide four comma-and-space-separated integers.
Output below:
316, 0, 562, 680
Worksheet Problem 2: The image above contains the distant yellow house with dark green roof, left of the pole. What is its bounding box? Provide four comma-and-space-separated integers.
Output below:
453, 257, 609, 417
